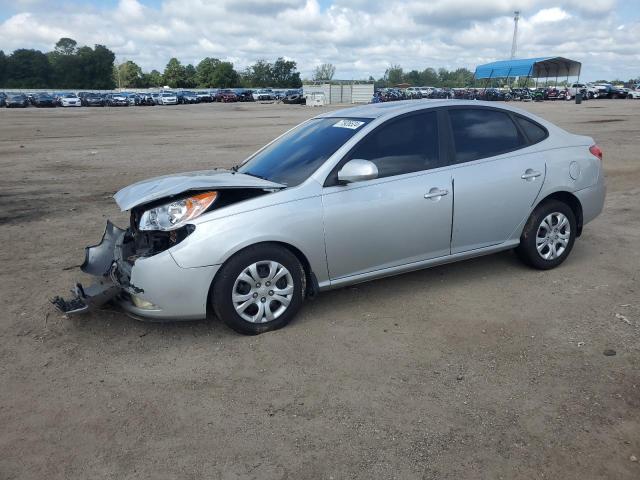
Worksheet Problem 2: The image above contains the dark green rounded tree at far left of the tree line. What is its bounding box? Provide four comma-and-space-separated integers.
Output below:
7, 48, 52, 88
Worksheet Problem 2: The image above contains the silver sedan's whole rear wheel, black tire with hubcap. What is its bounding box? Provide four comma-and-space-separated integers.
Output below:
516, 200, 577, 270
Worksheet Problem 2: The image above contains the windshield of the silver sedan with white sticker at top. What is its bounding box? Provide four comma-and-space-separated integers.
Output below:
238, 118, 370, 187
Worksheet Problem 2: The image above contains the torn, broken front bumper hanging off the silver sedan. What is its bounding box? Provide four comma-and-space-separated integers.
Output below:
51, 221, 219, 320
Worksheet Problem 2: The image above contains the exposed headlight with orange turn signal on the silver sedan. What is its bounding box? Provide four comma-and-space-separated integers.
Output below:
140, 192, 218, 232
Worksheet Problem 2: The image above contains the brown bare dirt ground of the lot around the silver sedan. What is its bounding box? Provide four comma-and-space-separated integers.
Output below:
0, 100, 640, 480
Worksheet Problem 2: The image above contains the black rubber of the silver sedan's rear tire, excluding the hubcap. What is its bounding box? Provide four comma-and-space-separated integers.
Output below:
516, 200, 578, 270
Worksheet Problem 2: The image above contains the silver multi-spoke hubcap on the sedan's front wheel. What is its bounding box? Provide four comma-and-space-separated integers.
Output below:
231, 260, 294, 323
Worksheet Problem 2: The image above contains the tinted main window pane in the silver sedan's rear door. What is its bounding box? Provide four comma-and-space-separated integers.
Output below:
449, 108, 525, 163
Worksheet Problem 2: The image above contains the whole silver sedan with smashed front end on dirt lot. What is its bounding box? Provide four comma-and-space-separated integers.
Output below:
54, 100, 605, 334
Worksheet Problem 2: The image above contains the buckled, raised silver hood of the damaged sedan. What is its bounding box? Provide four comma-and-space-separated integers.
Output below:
113, 169, 285, 212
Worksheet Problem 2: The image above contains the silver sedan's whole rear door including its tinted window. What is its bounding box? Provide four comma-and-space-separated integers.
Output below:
448, 107, 547, 254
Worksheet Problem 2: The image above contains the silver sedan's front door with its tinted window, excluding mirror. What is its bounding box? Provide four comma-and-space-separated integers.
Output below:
322, 112, 453, 280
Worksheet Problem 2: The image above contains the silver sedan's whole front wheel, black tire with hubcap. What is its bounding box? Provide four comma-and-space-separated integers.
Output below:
210, 243, 306, 335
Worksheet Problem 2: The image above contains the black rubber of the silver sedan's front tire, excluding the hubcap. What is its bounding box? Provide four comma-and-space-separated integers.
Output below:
210, 243, 306, 335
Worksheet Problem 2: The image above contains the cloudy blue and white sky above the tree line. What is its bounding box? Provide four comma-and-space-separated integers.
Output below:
0, 0, 640, 80
